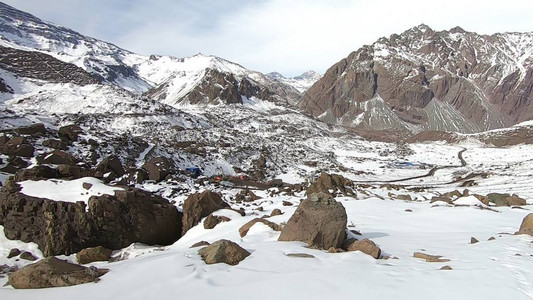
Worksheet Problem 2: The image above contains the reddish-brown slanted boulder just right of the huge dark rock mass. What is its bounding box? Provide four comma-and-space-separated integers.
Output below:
182, 191, 230, 235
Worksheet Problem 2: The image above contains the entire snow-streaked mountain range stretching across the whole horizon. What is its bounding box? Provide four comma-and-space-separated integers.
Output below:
0, 3, 533, 133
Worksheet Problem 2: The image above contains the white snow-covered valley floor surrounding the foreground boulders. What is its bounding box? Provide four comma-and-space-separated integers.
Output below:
0, 140, 533, 299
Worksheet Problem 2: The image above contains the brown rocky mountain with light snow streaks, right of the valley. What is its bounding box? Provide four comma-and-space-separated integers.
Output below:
300, 25, 533, 132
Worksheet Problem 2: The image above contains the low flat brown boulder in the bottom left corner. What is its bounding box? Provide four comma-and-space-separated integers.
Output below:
8, 256, 108, 289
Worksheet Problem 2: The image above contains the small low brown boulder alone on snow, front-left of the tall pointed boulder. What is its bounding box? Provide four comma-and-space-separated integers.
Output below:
198, 240, 250, 266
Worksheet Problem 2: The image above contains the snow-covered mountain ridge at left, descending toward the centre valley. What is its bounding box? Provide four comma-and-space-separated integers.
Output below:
0, 2, 300, 104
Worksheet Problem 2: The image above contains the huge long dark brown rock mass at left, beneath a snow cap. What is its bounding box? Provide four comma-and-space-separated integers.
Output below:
0, 181, 181, 256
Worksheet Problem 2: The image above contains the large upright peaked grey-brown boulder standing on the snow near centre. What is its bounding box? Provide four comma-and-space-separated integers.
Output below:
278, 193, 347, 250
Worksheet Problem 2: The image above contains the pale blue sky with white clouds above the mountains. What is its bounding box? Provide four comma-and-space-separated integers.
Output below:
0, 0, 533, 76
